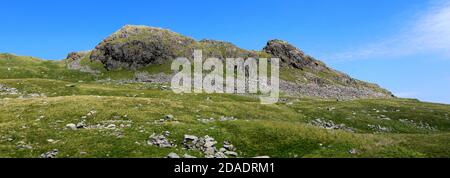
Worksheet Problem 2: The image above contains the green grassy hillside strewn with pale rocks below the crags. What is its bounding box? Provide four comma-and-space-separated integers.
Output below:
0, 54, 450, 158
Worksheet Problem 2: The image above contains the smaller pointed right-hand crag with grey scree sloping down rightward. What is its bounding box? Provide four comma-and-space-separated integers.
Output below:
263, 40, 394, 99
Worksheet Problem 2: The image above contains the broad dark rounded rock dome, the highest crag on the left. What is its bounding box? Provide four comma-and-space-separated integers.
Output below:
90, 25, 195, 69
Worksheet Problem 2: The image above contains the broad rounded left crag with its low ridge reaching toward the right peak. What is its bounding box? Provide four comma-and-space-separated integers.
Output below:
90, 25, 256, 70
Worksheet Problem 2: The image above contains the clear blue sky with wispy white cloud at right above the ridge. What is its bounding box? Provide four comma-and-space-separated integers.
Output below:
0, 0, 450, 103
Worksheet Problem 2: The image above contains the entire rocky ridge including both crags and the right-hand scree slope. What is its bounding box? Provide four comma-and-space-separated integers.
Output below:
71, 25, 393, 99
